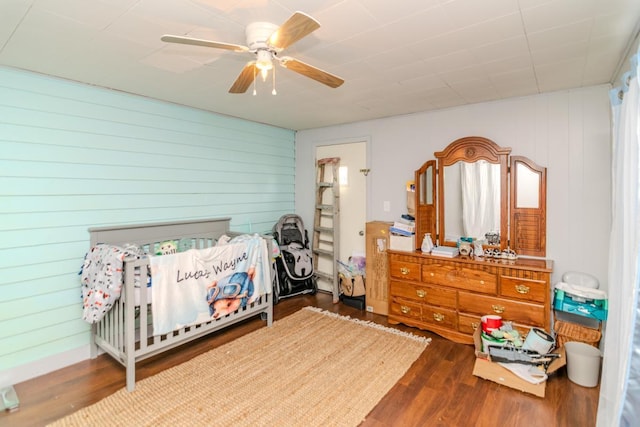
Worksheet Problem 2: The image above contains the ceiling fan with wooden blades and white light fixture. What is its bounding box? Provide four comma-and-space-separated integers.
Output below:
161, 12, 344, 94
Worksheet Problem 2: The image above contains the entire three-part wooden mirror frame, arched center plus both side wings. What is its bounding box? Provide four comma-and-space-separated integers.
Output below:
415, 136, 547, 257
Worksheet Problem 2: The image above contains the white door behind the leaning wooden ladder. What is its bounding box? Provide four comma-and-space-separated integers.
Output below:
316, 141, 368, 292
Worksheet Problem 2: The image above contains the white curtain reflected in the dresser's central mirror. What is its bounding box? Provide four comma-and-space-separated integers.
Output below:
460, 160, 500, 239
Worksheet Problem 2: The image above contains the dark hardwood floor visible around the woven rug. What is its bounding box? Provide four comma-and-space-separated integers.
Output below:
0, 293, 599, 427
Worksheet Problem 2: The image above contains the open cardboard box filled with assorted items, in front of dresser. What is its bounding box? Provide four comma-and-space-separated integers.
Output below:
473, 315, 566, 397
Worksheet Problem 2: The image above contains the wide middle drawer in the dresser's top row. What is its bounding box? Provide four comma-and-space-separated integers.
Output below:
422, 264, 498, 295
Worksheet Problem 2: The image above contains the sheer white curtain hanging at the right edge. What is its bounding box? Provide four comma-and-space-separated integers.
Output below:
597, 48, 640, 427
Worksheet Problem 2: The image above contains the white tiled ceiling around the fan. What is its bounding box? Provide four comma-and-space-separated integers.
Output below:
0, 0, 640, 130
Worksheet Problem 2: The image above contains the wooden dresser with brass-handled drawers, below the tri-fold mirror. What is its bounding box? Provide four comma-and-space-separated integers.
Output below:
388, 250, 553, 344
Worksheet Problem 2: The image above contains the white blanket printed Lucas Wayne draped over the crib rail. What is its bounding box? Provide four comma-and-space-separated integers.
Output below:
150, 234, 272, 335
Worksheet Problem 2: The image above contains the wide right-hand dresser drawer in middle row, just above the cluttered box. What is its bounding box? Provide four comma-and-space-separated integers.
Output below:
458, 292, 545, 327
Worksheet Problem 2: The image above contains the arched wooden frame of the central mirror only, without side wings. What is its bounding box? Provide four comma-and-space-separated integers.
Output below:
434, 136, 511, 249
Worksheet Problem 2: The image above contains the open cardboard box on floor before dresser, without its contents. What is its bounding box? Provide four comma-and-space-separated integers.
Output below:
473, 328, 567, 397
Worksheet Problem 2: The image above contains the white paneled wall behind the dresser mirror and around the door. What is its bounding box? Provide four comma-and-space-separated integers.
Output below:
296, 85, 611, 289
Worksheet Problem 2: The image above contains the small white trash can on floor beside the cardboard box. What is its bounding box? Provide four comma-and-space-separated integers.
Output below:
564, 341, 602, 387
